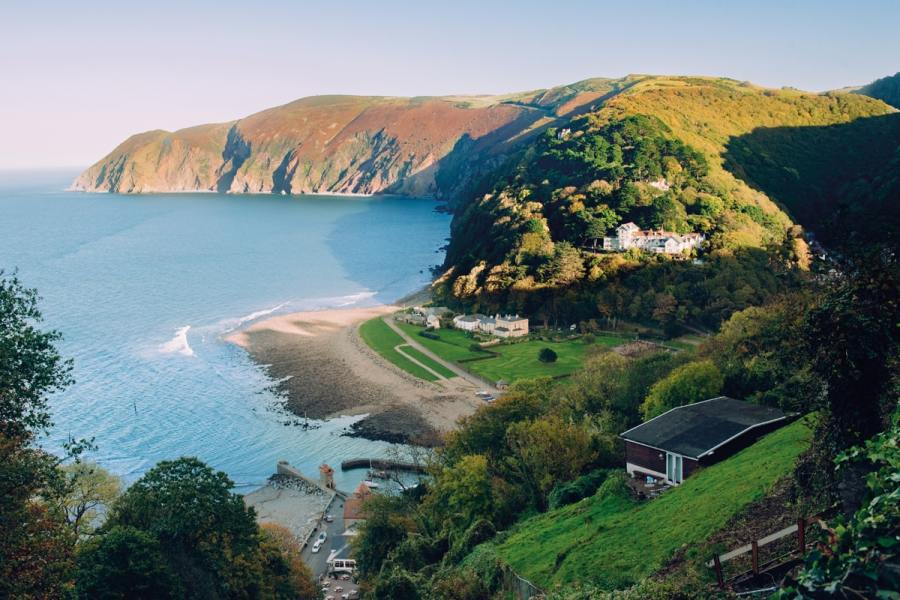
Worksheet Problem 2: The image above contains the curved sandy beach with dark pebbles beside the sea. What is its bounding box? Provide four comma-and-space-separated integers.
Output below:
225, 305, 478, 445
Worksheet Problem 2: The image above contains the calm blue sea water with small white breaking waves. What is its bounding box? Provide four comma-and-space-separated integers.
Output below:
0, 172, 449, 489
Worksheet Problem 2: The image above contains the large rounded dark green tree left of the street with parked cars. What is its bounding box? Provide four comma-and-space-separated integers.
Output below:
107, 458, 261, 597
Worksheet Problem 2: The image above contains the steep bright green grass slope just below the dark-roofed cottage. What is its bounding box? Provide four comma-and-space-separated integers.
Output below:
497, 421, 810, 590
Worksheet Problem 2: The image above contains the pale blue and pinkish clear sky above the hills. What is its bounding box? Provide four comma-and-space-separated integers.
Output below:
0, 0, 900, 169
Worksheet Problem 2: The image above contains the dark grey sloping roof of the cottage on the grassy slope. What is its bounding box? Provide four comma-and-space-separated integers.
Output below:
621, 396, 785, 458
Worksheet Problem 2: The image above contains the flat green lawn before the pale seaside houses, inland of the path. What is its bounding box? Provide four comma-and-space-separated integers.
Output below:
399, 323, 624, 383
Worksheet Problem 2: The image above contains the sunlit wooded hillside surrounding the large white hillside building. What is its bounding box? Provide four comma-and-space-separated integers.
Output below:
436, 76, 900, 327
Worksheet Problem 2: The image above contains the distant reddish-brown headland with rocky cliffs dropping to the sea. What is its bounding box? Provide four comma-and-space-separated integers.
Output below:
72, 85, 607, 198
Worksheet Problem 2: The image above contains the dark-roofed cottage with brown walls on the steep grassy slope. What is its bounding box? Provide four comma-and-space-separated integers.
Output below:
620, 396, 787, 485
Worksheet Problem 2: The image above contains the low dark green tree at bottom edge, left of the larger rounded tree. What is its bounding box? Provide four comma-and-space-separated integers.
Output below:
75, 526, 183, 600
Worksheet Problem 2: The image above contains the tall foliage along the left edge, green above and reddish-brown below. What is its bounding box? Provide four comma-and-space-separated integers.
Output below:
0, 271, 74, 599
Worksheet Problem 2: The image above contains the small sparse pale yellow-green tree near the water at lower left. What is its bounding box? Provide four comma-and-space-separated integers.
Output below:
60, 461, 122, 537
